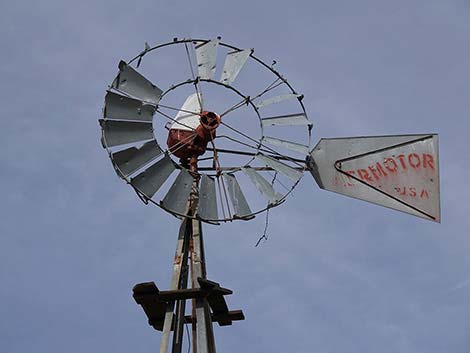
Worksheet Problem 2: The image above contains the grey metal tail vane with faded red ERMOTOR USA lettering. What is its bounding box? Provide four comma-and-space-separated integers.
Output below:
307, 134, 440, 222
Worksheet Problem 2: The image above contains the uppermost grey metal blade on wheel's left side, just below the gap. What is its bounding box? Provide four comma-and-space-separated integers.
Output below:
112, 61, 163, 105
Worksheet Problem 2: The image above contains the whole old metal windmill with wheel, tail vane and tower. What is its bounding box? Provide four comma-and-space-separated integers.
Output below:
99, 38, 440, 353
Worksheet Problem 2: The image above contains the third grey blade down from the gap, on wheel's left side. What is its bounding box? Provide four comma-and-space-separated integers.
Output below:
99, 119, 153, 147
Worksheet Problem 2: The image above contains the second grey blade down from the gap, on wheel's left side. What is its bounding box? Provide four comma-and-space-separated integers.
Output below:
104, 92, 155, 121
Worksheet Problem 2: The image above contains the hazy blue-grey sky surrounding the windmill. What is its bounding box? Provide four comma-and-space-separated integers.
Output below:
0, 0, 470, 353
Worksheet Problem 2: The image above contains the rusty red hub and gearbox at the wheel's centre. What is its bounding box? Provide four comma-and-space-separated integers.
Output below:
167, 111, 221, 171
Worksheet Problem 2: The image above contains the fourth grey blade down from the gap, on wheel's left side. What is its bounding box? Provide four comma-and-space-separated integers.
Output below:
111, 140, 162, 177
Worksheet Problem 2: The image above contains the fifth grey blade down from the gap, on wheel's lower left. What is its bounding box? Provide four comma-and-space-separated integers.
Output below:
131, 155, 176, 198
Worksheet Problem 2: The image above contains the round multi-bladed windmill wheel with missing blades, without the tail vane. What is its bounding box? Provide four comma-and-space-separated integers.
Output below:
100, 38, 312, 223
